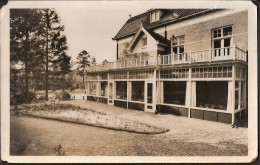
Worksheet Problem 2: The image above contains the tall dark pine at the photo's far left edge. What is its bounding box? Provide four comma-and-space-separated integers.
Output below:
10, 9, 42, 102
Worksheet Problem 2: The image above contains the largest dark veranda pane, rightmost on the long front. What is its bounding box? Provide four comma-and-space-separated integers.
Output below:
196, 81, 228, 110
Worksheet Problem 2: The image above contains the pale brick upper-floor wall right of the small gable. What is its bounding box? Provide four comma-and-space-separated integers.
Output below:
165, 11, 248, 52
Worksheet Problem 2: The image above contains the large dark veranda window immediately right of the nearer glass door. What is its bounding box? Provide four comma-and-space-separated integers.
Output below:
163, 81, 186, 105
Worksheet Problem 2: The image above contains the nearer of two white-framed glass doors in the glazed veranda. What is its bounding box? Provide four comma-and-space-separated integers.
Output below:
145, 81, 155, 111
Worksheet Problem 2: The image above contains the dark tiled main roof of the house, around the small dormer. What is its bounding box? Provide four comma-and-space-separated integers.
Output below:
113, 9, 220, 40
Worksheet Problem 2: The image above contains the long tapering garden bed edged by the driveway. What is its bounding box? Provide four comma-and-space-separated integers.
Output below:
11, 103, 169, 134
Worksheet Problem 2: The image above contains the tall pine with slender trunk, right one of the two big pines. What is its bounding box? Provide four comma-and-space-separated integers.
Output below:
42, 9, 70, 100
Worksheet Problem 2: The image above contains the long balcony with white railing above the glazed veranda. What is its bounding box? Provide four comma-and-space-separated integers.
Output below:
87, 47, 247, 72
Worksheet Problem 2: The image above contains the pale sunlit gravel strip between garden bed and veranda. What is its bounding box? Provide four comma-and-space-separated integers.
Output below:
62, 100, 248, 147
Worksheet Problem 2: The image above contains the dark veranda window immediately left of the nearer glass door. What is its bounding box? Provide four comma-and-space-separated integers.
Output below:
131, 81, 144, 102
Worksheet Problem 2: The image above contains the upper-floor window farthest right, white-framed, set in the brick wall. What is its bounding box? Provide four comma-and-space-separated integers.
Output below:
212, 26, 232, 57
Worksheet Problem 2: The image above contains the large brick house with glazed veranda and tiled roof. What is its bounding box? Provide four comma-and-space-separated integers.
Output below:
87, 9, 248, 124
